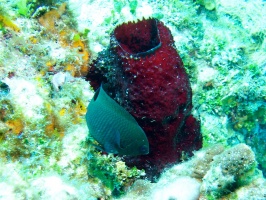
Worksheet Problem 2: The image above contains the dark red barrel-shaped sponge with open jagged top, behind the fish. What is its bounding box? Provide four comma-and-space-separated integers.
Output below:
86, 19, 202, 177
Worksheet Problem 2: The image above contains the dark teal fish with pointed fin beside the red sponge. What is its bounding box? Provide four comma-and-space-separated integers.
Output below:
86, 86, 149, 156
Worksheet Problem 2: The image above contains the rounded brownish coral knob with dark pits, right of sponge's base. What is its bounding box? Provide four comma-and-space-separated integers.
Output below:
201, 144, 257, 198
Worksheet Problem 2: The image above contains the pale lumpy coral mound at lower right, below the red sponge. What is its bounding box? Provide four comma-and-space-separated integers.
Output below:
123, 144, 266, 200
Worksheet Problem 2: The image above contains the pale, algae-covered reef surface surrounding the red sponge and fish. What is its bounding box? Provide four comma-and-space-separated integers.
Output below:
0, 0, 266, 200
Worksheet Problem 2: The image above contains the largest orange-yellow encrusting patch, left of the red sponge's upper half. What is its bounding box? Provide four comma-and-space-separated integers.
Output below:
39, 3, 90, 77
